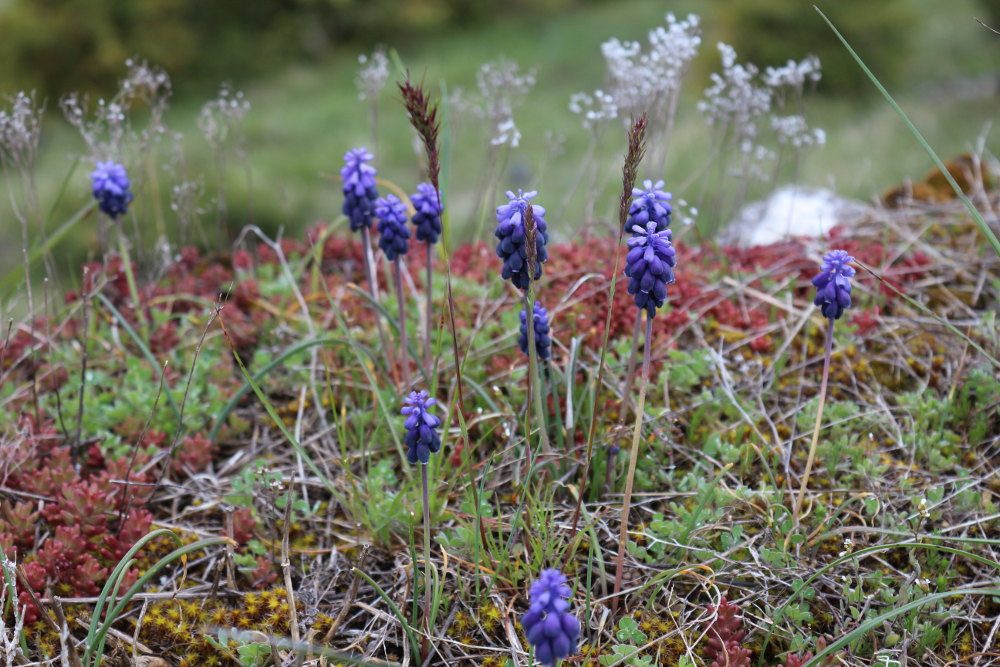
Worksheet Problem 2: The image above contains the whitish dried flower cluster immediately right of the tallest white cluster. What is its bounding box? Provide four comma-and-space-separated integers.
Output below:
698, 42, 771, 142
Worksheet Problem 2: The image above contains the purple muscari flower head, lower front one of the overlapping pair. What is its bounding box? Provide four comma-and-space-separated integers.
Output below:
625, 220, 677, 317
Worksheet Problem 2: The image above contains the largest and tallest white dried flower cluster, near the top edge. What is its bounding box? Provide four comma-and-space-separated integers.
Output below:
601, 14, 701, 118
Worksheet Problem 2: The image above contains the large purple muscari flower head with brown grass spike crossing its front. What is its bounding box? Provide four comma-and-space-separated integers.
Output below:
493, 190, 549, 289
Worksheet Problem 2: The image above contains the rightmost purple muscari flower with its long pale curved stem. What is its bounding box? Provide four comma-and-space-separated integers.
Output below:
785, 250, 856, 528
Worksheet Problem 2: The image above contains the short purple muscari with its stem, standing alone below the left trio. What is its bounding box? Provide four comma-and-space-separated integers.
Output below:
400, 390, 441, 633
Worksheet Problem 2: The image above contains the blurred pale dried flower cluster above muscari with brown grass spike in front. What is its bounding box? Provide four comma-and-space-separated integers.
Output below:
470, 59, 535, 148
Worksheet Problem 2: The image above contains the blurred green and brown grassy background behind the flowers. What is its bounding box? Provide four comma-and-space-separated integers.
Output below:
0, 0, 1000, 284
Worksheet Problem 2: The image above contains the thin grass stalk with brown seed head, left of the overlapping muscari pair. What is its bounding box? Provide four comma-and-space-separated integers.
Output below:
566, 114, 647, 563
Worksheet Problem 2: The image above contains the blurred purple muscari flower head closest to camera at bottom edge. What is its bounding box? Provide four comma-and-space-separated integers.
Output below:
521, 570, 580, 667
